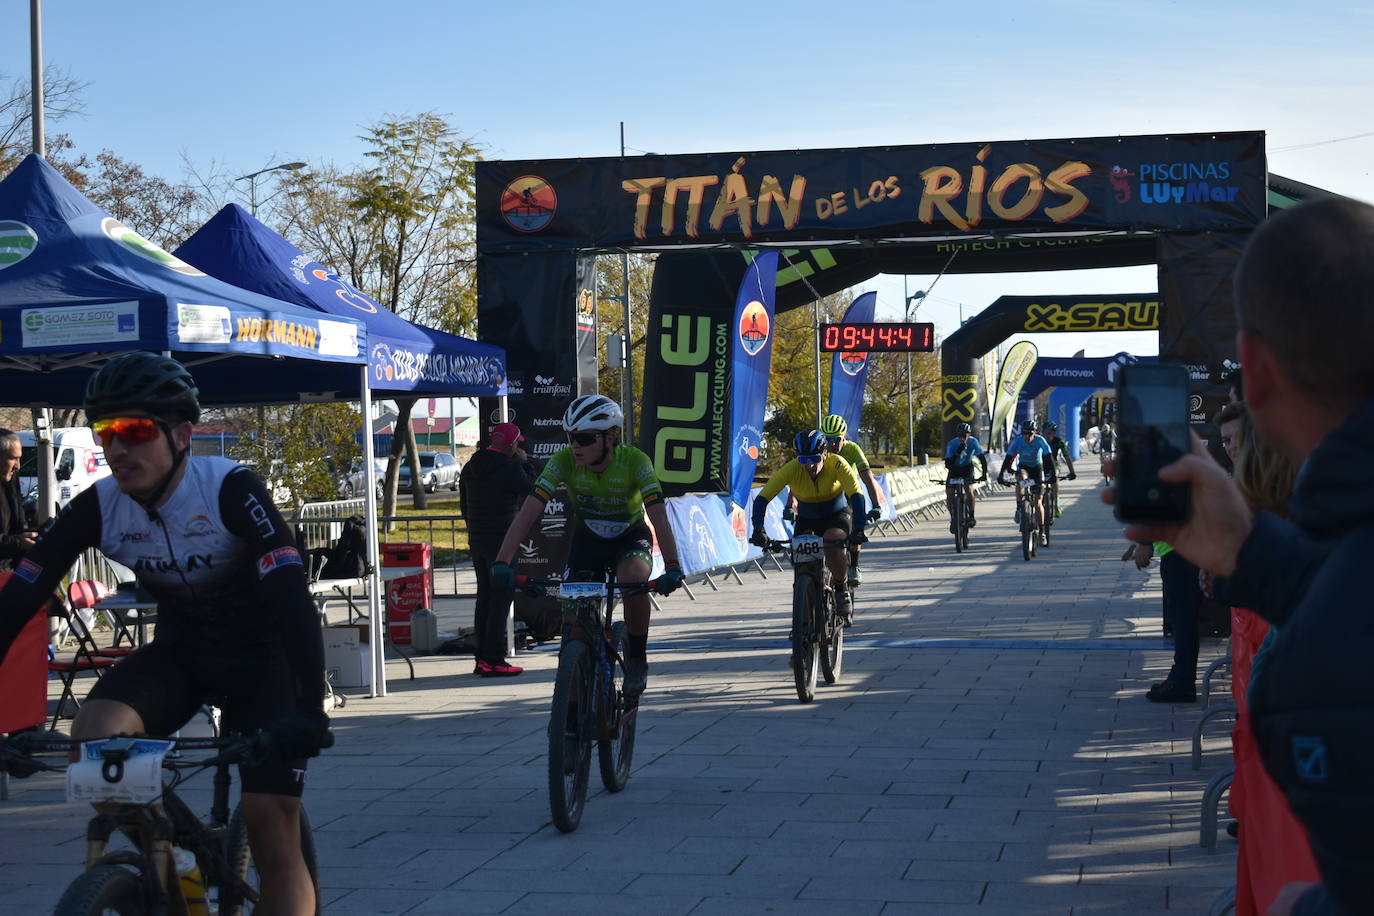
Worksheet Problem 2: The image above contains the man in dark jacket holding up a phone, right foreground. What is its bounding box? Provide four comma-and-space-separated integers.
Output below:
1109, 198, 1374, 916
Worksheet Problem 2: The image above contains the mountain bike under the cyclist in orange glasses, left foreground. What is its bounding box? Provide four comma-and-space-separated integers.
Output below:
0, 732, 324, 916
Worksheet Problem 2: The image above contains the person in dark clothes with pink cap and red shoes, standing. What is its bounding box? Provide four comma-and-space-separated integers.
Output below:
458, 423, 536, 677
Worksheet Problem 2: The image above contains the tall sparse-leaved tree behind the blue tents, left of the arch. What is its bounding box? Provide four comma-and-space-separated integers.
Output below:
273, 113, 482, 515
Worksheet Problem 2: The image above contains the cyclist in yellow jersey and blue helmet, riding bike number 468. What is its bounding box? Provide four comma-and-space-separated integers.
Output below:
749, 430, 868, 623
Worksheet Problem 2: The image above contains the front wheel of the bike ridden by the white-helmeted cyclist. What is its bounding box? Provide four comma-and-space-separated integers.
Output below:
548, 637, 594, 834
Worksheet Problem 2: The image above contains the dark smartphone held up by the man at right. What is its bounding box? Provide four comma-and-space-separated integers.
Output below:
1116, 363, 1189, 522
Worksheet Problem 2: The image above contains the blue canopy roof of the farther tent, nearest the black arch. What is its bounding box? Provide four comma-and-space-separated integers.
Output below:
176, 203, 506, 397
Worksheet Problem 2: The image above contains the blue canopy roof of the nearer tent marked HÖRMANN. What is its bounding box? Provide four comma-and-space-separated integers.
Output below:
0, 155, 367, 407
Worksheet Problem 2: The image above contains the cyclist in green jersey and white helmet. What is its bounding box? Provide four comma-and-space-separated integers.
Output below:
492, 394, 684, 694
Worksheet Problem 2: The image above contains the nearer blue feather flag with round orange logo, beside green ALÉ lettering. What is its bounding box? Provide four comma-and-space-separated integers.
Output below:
730, 251, 778, 508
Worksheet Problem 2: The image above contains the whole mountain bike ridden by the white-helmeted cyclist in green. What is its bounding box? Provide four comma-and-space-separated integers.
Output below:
515, 575, 654, 834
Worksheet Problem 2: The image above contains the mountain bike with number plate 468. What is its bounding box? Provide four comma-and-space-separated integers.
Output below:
763, 534, 848, 703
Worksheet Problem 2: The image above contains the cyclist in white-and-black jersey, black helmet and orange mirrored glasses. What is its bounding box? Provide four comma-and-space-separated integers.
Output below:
0, 353, 333, 916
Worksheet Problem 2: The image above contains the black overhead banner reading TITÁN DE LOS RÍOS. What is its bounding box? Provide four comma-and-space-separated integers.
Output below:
477, 132, 1267, 254
